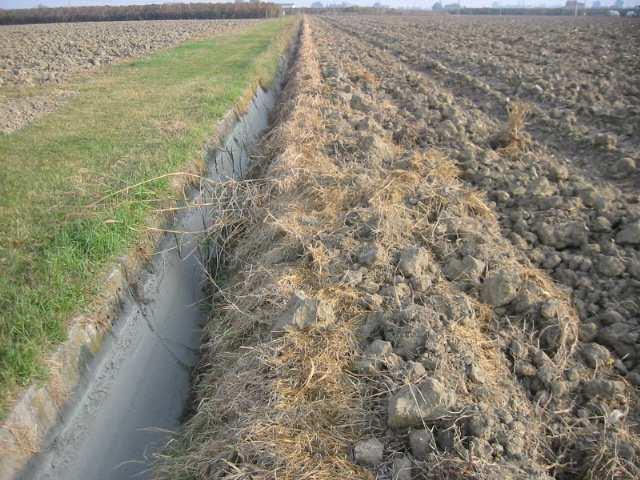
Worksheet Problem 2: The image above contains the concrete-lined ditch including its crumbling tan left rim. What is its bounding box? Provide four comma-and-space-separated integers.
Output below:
0, 25, 297, 480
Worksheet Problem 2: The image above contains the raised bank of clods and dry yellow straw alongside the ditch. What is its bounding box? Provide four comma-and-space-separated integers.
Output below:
160, 15, 640, 480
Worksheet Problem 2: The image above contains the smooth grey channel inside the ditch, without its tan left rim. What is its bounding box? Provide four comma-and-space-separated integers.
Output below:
22, 46, 291, 480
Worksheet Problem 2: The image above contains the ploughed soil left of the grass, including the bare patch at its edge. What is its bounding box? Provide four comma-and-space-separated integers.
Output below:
0, 20, 255, 132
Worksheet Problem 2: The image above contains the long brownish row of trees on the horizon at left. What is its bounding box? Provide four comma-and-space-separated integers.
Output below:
0, 3, 283, 25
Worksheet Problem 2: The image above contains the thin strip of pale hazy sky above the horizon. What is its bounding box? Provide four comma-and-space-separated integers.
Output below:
0, 0, 640, 8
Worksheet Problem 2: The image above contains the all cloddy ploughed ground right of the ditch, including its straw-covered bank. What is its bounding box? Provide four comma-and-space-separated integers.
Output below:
160, 16, 640, 480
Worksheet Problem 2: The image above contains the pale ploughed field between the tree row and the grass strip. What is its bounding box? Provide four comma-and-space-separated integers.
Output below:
0, 20, 254, 86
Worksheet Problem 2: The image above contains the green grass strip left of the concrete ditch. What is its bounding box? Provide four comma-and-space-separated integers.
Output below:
0, 18, 295, 417
